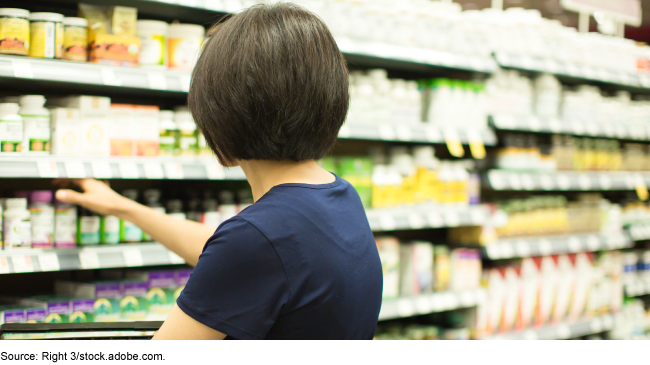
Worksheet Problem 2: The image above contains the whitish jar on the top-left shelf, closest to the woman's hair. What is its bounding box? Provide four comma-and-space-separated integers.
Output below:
168, 24, 205, 71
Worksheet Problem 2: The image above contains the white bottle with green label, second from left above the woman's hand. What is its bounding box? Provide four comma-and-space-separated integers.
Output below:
18, 95, 51, 155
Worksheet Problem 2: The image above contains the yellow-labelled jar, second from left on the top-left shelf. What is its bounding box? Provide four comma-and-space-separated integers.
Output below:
29, 13, 63, 58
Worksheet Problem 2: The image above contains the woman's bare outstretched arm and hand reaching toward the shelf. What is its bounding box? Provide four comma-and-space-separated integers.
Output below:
56, 179, 215, 266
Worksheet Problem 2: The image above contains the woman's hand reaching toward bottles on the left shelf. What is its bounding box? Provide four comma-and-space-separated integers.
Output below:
55, 179, 133, 216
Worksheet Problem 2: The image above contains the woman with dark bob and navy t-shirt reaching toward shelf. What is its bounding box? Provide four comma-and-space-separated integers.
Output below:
56, 4, 382, 339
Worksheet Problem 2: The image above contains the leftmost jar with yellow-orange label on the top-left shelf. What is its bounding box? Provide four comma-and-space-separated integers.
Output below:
0, 8, 30, 56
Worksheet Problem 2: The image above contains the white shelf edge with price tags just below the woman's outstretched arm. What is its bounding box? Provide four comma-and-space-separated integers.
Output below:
0, 243, 185, 274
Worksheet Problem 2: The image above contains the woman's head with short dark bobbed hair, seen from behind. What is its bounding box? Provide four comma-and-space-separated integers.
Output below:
188, 4, 349, 165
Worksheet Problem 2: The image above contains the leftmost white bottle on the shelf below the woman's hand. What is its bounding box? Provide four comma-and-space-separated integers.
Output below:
2, 198, 32, 250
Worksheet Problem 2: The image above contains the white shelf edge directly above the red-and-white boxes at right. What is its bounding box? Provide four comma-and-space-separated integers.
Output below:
481, 232, 634, 260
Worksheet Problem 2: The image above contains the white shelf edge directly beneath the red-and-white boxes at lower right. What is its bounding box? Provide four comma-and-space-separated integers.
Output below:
481, 314, 623, 340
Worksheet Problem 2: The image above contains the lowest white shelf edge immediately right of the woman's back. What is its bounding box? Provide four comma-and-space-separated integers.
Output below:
379, 289, 485, 321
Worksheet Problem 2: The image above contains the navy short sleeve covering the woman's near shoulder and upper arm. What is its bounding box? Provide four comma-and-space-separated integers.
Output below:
177, 217, 288, 340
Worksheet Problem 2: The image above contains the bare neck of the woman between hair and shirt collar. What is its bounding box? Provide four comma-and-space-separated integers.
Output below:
239, 160, 336, 201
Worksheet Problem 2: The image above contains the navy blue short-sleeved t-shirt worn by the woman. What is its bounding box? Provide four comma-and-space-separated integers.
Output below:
177, 176, 382, 339
